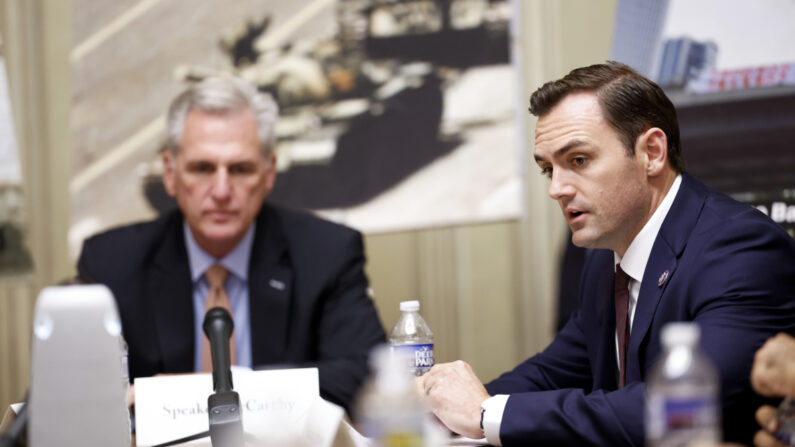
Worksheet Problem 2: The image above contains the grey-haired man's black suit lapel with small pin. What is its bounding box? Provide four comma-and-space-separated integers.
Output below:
248, 204, 293, 367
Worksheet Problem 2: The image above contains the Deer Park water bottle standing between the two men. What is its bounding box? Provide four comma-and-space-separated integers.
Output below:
389, 301, 433, 376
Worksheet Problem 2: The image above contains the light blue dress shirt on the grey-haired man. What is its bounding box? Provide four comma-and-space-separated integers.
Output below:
183, 223, 254, 371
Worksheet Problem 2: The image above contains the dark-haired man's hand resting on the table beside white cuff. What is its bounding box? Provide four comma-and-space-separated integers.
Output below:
414, 360, 490, 439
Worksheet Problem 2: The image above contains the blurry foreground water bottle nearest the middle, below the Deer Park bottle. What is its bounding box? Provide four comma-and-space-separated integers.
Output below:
356, 345, 428, 447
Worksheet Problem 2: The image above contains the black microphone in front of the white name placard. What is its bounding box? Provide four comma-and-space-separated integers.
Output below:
202, 307, 243, 447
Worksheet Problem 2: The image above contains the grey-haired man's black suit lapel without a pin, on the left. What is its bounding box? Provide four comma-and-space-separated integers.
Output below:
146, 217, 195, 372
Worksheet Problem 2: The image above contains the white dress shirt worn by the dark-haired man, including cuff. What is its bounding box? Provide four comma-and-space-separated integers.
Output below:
480, 175, 682, 446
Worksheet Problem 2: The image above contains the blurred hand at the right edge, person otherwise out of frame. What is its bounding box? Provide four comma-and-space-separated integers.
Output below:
751, 333, 795, 397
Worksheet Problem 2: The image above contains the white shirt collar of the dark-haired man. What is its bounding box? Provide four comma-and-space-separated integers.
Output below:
613, 174, 682, 282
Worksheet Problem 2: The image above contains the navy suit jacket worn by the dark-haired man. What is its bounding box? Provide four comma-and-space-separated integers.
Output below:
486, 174, 795, 447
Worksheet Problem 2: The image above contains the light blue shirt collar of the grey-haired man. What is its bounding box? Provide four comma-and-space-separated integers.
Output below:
182, 222, 254, 282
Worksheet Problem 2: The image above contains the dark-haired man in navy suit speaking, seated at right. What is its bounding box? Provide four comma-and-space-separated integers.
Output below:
416, 62, 795, 446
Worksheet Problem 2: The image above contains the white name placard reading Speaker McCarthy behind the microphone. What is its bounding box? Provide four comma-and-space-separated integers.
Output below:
135, 368, 322, 446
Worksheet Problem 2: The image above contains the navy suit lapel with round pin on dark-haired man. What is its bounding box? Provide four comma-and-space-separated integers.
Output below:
627, 174, 705, 383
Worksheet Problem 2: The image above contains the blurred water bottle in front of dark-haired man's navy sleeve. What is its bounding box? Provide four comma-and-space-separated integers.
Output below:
646, 323, 721, 447
